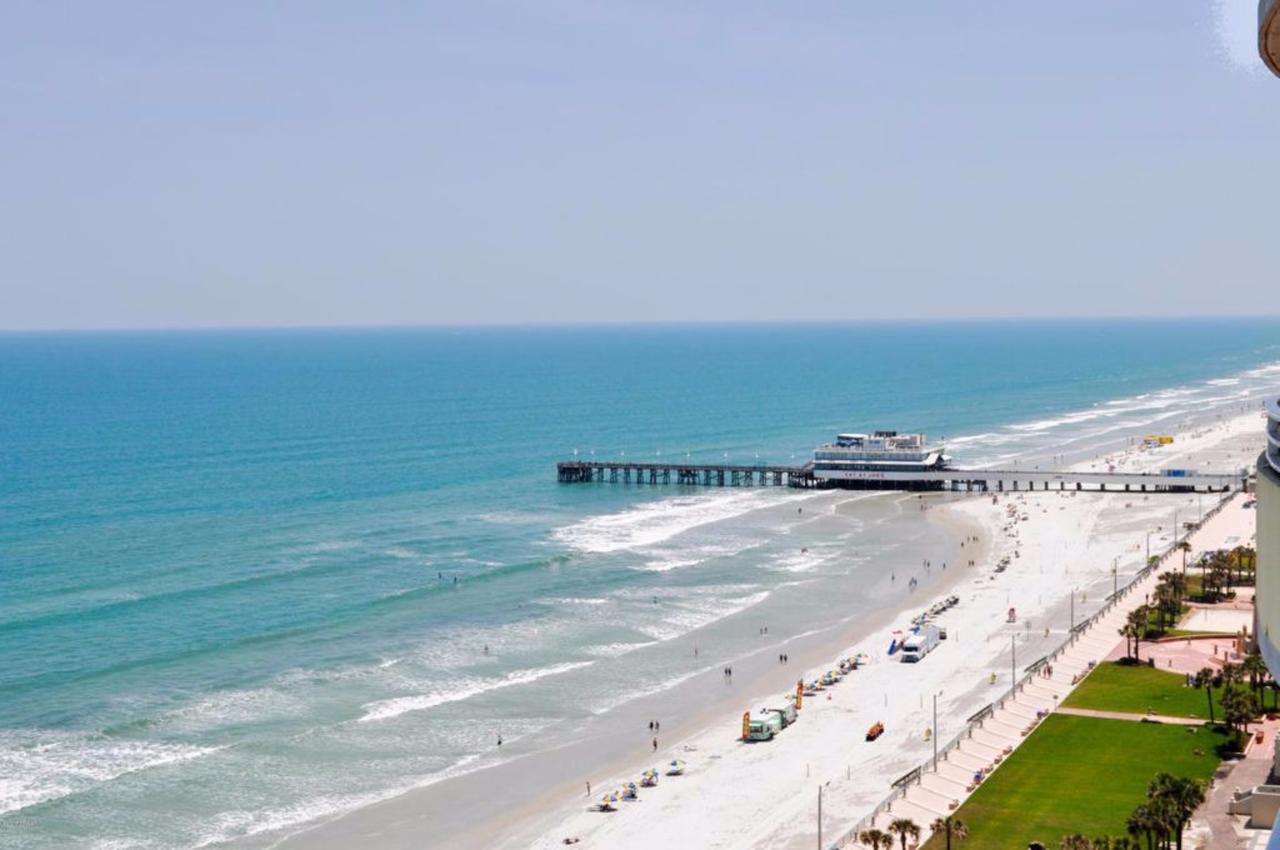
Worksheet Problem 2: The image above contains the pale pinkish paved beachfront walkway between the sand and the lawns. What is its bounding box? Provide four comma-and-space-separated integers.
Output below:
831, 498, 1234, 847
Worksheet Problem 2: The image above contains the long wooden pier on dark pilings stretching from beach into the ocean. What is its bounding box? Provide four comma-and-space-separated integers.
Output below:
557, 461, 1249, 493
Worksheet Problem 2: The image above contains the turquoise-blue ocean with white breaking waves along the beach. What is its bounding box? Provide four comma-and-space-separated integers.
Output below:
0, 320, 1280, 850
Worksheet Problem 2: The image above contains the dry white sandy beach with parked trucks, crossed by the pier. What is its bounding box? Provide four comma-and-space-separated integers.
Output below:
512, 412, 1262, 850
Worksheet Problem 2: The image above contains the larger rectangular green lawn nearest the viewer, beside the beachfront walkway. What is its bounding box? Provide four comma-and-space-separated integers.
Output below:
920, 714, 1225, 850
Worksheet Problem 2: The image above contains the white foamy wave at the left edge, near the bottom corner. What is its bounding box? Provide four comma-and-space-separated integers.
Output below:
0, 730, 225, 814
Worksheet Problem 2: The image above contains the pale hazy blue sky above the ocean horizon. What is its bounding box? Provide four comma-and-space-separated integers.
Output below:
0, 0, 1280, 330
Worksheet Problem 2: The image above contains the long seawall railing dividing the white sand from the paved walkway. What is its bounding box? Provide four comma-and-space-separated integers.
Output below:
831, 494, 1231, 850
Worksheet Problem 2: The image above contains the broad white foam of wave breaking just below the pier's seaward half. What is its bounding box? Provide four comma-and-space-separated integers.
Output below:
552, 492, 786, 553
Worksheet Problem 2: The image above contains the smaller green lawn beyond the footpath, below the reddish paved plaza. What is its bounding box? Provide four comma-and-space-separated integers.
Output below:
1062, 662, 1222, 719
